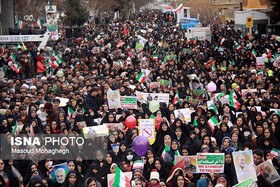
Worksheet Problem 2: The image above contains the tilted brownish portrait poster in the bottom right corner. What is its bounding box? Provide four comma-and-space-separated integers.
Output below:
256, 159, 280, 183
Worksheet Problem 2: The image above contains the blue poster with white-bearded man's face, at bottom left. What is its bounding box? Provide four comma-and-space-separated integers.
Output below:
49, 162, 69, 184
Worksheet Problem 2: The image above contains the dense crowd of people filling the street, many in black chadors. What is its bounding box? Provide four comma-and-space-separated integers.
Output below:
0, 12, 280, 187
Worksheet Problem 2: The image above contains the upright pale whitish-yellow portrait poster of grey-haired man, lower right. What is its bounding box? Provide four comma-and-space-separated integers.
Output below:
232, 150, 257, 182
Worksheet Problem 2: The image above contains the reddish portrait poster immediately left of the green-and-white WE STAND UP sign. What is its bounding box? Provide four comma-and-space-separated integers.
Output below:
175, 156, 196, 173
